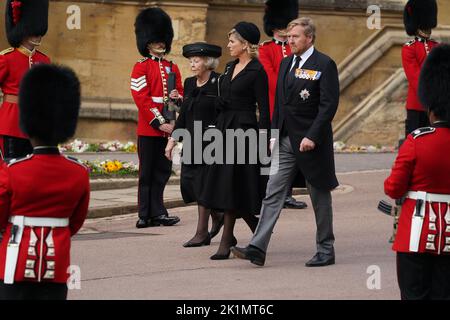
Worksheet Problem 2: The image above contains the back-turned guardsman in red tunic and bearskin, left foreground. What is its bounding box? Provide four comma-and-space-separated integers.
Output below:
0, 64, 89, 300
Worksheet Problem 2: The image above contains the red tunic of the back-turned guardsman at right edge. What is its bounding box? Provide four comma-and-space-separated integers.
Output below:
384, 127, 450, 254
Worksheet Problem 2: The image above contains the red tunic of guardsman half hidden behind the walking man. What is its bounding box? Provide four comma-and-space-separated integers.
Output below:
259, 39, 291, 120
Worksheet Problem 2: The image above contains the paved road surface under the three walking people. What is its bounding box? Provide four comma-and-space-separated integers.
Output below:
69, 154, 399, 299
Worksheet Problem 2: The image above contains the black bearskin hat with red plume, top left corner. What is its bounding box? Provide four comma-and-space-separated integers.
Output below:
5, 0, 49, 48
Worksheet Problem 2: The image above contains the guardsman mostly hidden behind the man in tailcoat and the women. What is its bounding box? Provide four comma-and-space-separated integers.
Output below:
259, 0, 307, 209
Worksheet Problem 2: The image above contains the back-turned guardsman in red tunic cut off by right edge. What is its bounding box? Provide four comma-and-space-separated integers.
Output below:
384, 45, 450, 299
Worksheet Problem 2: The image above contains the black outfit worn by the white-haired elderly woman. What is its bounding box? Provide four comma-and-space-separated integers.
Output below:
174, 72, 219, 203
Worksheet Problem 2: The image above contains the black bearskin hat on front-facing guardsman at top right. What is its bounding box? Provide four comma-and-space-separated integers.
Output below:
403, 0, 438, 36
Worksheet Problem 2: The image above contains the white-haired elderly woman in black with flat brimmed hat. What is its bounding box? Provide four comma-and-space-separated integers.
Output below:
166, 43, 223, 247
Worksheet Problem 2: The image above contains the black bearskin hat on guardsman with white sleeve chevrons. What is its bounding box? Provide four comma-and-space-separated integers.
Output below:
134, 8, 173, 57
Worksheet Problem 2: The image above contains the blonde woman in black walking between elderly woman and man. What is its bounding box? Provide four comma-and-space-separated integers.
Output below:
198, 22, 270, 260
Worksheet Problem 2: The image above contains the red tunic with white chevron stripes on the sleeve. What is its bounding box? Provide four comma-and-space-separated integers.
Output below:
131, 56, 183, 137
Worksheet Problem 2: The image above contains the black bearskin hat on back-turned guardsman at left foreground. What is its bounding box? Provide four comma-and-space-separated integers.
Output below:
19, 64, 81, 145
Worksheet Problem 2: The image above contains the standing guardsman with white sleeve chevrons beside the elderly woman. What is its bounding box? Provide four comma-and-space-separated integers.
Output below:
131, 8, 183, 228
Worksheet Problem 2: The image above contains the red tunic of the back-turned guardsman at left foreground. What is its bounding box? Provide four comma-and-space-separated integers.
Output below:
0, 148, 89, 283
